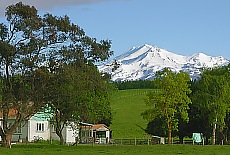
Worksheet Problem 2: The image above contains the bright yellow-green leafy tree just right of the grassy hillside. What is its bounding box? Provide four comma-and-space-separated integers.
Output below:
142, 68, 191, 143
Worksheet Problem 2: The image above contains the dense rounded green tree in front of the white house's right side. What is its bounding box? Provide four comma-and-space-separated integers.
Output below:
51, 64, 112, 144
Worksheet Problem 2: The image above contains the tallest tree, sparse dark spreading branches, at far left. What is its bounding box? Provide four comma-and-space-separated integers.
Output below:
0, 2, 112, 146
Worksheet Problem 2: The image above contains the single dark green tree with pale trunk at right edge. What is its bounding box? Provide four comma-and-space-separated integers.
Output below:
192, 65, 230, 144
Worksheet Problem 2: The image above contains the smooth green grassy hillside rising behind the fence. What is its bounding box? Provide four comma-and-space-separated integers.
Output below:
110, 89, 153, 138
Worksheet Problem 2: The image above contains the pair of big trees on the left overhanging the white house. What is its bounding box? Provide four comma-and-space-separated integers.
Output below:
0, 2, 113, 146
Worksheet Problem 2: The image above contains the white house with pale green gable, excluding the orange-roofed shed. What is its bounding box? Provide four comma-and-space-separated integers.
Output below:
0, 109, 78, 143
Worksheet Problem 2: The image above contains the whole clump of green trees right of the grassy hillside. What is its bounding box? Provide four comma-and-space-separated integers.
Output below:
142, 64, 230, 144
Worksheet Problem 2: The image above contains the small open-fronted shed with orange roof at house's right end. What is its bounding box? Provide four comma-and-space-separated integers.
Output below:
93, 124, 112, 144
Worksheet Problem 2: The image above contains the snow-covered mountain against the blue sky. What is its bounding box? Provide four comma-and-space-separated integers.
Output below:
99, 45, 229, 81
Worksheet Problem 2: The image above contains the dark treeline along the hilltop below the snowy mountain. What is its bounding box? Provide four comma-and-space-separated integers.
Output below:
115, 80, 154, 90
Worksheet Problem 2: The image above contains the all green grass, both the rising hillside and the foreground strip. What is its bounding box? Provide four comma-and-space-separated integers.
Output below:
0, 90, 230, 155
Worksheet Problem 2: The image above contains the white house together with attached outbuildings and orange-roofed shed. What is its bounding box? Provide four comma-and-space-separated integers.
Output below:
0, 110, 111, 144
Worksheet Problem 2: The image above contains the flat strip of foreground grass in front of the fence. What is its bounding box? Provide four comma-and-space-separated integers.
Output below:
0, 144, 230, 155
